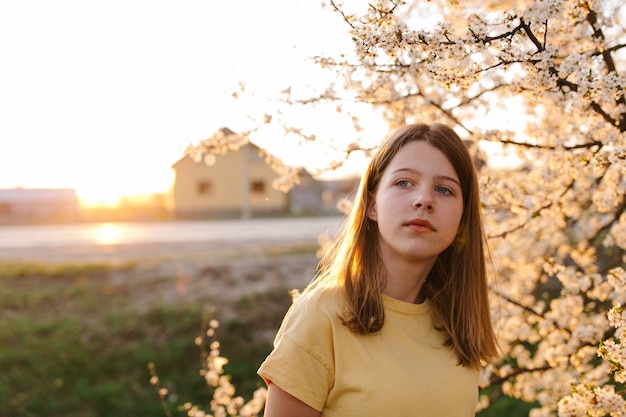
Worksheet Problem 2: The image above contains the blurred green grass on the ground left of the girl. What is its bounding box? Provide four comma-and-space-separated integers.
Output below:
0, 258, 290, 417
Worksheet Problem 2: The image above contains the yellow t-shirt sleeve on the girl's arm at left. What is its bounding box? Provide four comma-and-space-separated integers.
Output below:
258, 290, 334, 411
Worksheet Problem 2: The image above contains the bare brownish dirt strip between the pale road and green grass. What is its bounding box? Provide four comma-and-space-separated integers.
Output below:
0, 240, 319, 319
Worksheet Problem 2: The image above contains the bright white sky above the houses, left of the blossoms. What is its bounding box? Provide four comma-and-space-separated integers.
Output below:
0, 0, 366, 205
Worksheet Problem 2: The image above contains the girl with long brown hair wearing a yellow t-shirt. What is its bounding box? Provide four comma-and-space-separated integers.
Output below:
259, 124, 497, 417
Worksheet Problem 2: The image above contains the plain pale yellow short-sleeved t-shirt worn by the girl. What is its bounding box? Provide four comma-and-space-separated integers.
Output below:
258, 288, 478, 417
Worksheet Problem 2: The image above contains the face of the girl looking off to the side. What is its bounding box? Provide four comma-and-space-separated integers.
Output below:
367, 141, 463, 263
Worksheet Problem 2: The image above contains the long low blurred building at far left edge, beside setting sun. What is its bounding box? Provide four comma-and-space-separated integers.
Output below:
0, 188, 80, 222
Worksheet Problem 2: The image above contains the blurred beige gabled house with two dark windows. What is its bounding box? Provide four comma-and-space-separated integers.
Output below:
172, 128, 323, 218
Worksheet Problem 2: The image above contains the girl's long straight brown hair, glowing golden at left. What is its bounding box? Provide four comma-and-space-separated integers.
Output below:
308, 123, 497, 368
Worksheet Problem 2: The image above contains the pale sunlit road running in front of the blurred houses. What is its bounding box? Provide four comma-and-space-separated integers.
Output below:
0, 216, 343, 261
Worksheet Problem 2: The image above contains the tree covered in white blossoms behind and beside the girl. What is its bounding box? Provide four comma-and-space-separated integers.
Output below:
190, 0, 626, 417
